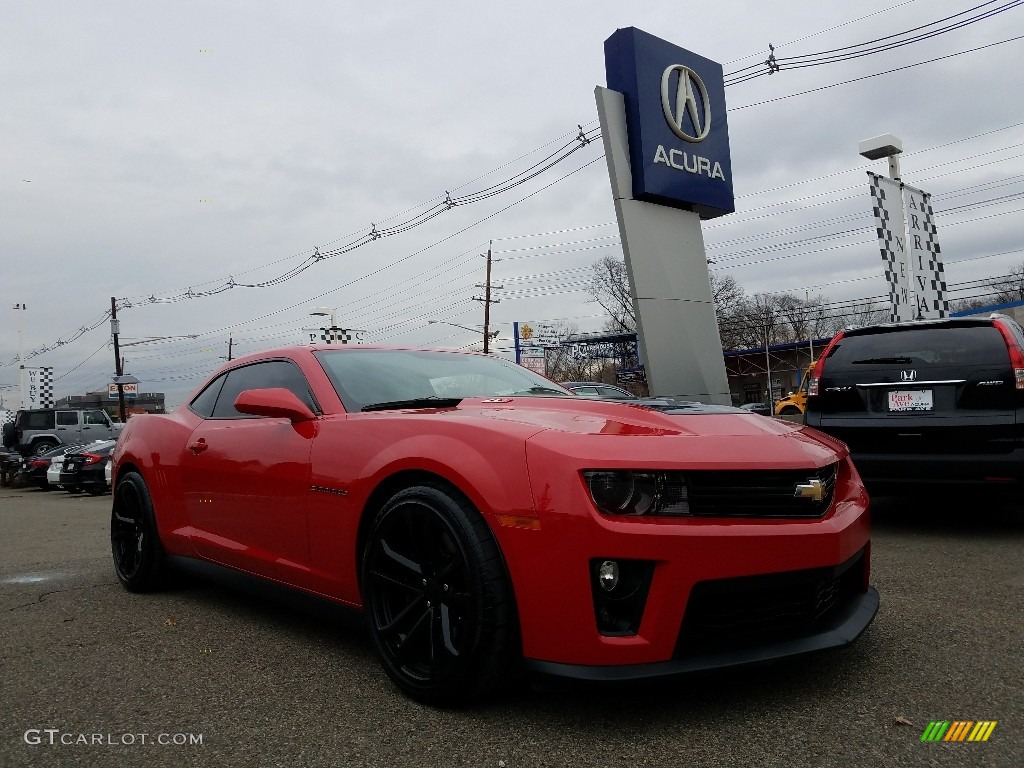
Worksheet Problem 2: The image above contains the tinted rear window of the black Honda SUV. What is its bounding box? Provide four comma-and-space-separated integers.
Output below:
825, 326, 1010, 374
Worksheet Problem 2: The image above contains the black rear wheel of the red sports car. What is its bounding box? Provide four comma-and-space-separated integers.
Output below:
111, 472, 164, 592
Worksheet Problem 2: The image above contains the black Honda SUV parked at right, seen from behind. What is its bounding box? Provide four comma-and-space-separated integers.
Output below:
805, 314, 1024, 490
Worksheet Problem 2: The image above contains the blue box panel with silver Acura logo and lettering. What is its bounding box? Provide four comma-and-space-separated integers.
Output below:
604, 27, 735, 219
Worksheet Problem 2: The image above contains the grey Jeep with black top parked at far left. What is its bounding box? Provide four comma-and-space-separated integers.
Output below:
3, 408, 124, 455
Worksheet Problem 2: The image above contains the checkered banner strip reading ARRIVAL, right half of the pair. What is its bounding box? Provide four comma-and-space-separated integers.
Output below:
903, 184, 949, 319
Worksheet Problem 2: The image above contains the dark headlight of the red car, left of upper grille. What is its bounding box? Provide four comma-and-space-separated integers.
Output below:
583, 470, 689, 515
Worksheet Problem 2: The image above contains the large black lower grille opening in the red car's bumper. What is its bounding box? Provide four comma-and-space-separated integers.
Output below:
676, 551, 864, 656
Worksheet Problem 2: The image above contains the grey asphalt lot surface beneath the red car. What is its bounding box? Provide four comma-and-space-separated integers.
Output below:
0, 487, 1024, 768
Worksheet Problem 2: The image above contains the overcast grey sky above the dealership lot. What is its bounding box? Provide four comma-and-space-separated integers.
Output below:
6, 0, 1024, 408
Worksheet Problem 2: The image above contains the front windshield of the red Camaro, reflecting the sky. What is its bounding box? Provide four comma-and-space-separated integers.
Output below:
316, 349, 572, 412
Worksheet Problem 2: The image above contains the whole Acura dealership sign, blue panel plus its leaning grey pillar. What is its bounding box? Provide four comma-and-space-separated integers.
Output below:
595, 28, 733, 404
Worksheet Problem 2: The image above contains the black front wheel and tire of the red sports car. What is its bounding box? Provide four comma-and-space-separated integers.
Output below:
362, 485, 516, 707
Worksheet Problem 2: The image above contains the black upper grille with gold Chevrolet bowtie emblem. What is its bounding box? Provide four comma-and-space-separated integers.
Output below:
686, 464, 837, 517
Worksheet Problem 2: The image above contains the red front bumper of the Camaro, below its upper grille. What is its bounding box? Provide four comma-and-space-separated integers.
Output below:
503, 444, 878, 678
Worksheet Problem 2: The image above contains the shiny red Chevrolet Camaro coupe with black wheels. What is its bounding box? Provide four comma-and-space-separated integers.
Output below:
111, 346, 879, 705
